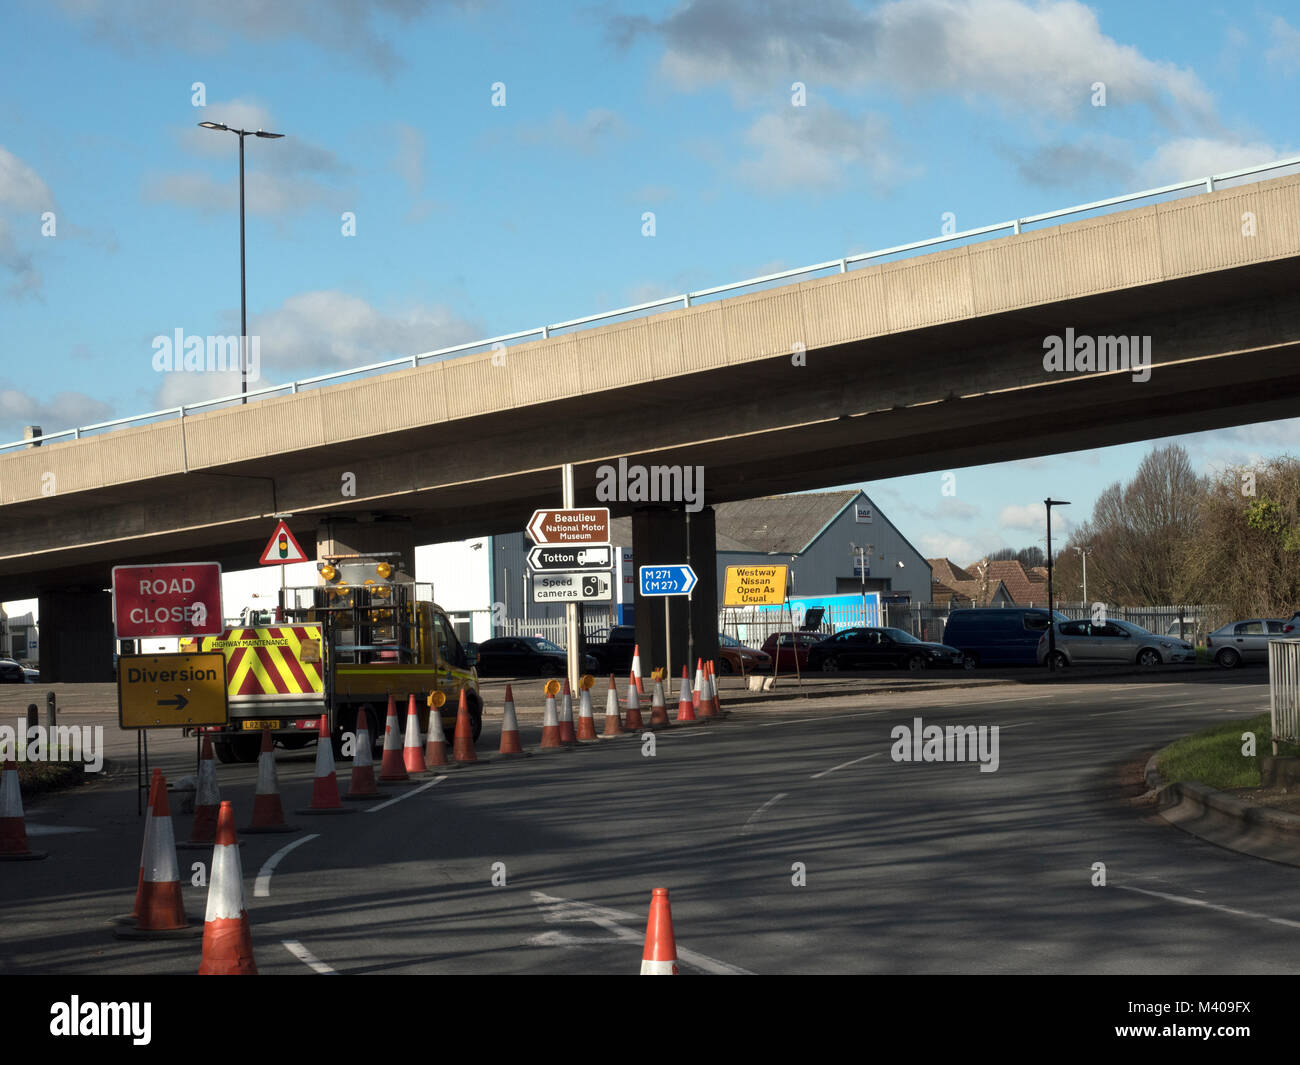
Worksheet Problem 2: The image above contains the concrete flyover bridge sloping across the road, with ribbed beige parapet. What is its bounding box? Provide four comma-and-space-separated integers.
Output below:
0, 163, 1300, 679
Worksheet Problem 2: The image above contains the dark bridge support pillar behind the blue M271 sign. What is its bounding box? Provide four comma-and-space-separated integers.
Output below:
632, 507, 718, 681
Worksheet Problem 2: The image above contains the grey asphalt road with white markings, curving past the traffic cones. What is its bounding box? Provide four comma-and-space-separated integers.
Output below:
0, 671, 1300, 975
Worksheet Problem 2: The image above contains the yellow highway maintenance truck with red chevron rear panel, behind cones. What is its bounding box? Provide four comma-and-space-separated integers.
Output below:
181, 554, 482, 762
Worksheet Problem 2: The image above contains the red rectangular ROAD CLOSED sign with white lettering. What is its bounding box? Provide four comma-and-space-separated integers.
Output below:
113, 562, 225, 640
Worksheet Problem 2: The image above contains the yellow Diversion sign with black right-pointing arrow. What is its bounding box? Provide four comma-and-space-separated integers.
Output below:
117, 651, 229, 728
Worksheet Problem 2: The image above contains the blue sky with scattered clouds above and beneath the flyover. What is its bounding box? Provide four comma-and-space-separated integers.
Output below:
0, 0, 1300, 574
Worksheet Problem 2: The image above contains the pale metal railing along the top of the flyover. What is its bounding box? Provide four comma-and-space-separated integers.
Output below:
0, 156, 1300, 451
